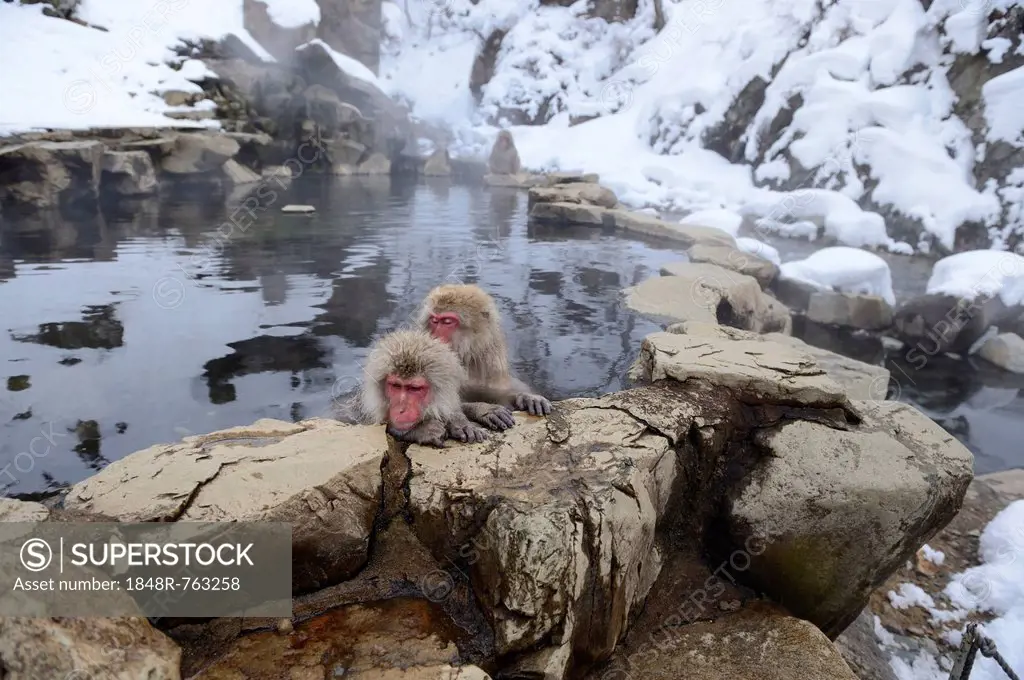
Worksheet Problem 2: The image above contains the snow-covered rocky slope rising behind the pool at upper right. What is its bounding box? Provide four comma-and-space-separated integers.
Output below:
382, 0, 1024, 252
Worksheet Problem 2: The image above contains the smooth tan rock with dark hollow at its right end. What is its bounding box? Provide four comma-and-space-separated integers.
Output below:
624, 262, 793, 333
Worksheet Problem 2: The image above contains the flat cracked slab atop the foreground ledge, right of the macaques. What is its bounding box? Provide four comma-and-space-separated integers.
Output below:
630, 332, 855, 414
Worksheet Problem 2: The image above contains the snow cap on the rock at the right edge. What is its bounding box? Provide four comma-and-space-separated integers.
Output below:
926, 250, 1024, 305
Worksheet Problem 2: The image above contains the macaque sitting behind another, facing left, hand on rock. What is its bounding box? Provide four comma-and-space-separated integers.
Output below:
417, 284, 551, 413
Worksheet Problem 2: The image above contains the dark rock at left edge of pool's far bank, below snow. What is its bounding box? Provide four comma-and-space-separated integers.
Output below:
0, 141, 105, 209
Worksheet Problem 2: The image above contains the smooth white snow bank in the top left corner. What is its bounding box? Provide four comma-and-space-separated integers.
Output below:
0, 0, 269, 134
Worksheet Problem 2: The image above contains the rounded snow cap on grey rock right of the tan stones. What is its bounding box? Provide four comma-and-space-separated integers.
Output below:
779, 246, 896, 305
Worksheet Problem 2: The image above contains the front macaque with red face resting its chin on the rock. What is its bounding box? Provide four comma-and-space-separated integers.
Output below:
359, 330, 487, 448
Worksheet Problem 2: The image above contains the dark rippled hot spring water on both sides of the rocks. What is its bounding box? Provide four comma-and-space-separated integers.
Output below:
0, 178, 1024, 495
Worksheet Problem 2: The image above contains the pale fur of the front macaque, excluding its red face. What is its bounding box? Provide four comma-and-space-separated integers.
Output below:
359, 330, 487, 447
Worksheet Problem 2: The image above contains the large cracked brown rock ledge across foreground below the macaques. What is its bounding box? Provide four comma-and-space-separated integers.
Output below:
0, 322, 973, 680
